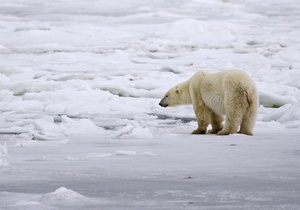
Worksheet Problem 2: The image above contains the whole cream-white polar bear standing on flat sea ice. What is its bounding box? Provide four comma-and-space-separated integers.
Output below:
159, 70, 259, 135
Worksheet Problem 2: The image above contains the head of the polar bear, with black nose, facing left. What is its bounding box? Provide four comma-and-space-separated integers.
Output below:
159, 84, 191, 107
